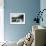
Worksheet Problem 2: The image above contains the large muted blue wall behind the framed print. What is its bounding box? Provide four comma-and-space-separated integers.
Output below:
4, 0, 40, 41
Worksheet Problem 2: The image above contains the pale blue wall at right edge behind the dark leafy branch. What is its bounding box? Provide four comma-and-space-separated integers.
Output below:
40, 0, 46, 27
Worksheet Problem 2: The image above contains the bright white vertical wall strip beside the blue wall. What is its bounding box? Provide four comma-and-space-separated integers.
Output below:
0, 0, 4, 42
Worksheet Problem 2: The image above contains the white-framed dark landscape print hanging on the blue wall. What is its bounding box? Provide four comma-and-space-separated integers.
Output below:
10, 13, 25, 24
